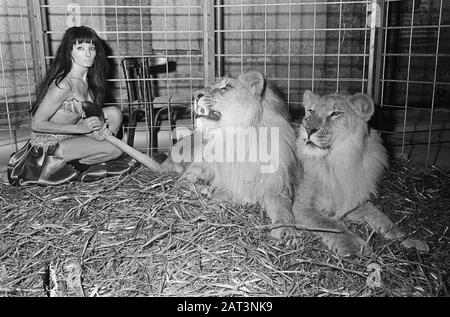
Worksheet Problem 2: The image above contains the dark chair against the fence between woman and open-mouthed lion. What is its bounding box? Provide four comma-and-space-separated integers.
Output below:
121, 57, 190, 155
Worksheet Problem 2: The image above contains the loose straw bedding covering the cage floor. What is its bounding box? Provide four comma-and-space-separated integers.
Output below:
0, 162, 450, 296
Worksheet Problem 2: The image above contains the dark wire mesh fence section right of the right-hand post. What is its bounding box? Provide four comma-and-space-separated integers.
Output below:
378, 0, 450, 164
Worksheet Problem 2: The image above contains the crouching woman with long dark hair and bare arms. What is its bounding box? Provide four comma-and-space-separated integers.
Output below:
8, 26, 134, 185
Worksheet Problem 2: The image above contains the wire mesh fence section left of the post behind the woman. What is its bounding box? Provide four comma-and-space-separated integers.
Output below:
0, 0, 36, 171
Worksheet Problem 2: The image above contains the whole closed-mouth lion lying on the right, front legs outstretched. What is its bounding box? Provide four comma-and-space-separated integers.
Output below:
292, 91, 428, 255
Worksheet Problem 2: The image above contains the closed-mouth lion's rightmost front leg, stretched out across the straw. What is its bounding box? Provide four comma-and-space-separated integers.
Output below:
346, 202, 430, 252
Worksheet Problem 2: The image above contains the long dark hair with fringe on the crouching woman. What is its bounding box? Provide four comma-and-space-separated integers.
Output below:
31, 26, 109, 115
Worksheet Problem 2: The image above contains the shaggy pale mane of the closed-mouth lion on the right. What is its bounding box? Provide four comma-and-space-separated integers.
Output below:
297, 90, 388, 216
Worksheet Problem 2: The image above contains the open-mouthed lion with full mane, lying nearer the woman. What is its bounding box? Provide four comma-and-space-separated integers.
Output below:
163, 71, 296, 238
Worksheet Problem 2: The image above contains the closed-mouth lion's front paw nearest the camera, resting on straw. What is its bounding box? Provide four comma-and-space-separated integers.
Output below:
325, 234, 372, 257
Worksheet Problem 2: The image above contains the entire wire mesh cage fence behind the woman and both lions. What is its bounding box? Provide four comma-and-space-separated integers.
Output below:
0, 0, 450, 173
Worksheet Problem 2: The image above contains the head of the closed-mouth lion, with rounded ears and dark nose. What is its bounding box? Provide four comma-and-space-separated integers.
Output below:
299, 91, 374, 157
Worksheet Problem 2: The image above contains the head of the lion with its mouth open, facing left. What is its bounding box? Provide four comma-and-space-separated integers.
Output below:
194, 74, 263, 131
